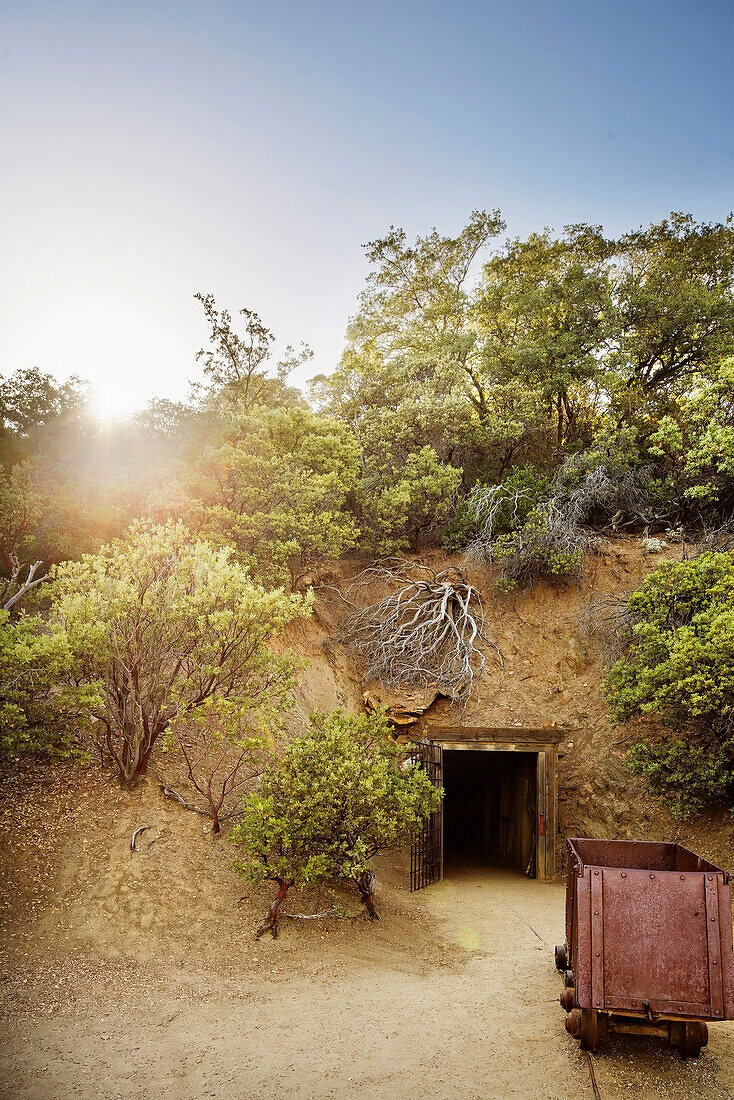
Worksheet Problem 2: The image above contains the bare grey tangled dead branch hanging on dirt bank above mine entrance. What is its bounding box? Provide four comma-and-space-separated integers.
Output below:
343, 559, 500, 705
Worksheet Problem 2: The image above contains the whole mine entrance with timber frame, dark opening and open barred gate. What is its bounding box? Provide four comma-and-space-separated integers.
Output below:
410, 727, 563, 890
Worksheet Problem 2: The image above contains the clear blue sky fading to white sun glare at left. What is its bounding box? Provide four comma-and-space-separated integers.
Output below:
0, 0, 734, 414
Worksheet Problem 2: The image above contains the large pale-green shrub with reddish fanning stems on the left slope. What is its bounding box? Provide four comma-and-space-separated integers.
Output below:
52, 523, 310, 784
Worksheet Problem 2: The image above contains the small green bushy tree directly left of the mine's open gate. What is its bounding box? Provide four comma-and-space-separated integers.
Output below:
231, 711, 441, 936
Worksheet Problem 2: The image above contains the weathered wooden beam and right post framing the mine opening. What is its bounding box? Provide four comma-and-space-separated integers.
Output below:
425, 726, 566, 881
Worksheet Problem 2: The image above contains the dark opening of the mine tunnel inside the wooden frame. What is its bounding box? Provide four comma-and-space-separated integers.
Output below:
443, 749, 538, 877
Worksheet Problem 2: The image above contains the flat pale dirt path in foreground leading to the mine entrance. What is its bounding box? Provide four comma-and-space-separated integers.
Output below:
0, 870, 734, 1100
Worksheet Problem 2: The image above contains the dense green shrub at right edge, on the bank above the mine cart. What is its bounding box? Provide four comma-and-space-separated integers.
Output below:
604, 552, 734, 810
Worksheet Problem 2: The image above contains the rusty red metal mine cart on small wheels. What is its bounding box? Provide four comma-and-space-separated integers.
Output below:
556, 838, 734, 1056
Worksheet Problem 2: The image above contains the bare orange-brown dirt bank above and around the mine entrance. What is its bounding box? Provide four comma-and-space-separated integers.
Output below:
287, 538, 734, 867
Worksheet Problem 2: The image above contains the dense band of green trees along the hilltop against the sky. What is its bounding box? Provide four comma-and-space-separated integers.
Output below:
0, 210, 734, 602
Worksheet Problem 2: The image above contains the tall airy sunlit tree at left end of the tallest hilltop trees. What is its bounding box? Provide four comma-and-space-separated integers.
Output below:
314, 210, 517, 490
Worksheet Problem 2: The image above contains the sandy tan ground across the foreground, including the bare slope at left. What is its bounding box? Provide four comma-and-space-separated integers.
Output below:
0, 766, 734, 1100
